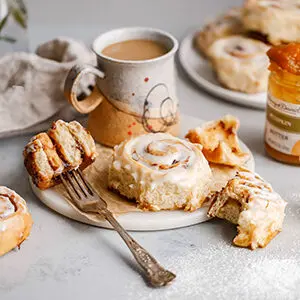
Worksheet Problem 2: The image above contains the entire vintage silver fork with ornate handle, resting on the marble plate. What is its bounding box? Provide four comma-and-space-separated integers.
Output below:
60, 169, 176, 287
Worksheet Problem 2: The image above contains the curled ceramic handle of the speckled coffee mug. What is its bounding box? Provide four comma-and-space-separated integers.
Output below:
64, 65, 105, 114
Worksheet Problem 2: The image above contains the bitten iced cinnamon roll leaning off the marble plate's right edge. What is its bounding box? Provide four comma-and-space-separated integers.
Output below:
208, 169, 286, 249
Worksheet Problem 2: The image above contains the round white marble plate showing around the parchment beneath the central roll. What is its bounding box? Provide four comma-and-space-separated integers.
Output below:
30, 115, 254, 231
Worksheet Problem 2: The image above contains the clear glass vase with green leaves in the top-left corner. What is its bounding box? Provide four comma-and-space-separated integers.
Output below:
0, 0, 28, 57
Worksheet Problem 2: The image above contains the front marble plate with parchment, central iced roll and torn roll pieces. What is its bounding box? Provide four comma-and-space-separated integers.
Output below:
23, 116, 254, 230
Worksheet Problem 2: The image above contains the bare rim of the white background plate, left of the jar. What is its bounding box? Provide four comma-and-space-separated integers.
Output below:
179, 31, 267, 109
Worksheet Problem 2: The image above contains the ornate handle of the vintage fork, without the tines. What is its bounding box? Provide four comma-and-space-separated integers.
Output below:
98, 208, 176, 287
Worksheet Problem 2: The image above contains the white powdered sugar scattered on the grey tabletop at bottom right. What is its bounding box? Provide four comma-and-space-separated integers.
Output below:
127, 202, 300, 300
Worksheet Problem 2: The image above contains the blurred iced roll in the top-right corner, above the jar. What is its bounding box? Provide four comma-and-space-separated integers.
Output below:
242, 0, 300, 45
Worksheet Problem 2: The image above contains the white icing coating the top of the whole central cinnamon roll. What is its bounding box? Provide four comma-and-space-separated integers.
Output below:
113, 133, 211, 187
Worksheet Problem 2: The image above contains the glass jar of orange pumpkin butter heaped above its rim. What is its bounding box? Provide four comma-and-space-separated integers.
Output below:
265, 43, 300, 166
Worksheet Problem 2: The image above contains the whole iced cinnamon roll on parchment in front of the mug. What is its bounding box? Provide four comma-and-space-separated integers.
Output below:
108, 133, 212, 211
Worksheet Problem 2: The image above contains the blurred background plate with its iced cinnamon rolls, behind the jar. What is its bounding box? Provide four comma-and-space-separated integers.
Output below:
179, 0, 300, 109
